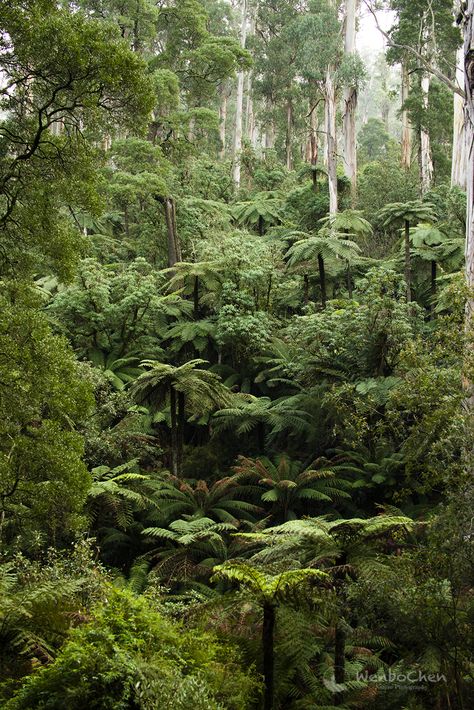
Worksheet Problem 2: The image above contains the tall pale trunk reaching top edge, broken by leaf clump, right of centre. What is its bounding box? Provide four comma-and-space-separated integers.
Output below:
343, 0, 358, 206
